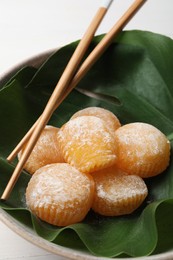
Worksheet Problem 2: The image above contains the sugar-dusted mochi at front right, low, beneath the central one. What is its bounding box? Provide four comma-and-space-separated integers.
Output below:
92, 167, 148, 216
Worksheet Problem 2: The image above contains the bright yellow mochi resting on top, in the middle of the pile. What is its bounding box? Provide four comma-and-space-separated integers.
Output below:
57, 116, 117, 173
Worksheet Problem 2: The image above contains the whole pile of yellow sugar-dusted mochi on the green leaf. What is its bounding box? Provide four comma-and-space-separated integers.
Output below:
18, 107, 170, 226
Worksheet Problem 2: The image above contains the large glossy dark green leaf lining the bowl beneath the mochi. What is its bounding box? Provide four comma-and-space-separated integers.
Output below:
0, 31, 173, 257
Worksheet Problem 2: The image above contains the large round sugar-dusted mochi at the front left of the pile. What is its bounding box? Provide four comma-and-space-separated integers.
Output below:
26, 163, 94, 226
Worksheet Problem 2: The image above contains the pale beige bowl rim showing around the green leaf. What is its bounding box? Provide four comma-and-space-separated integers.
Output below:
0, 47, 173, 260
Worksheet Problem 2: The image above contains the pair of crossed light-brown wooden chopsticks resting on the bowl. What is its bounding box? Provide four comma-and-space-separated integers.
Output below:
1, 0, 146, 200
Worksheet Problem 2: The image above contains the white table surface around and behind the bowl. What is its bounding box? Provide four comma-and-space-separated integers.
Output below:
0, 0, 173, 260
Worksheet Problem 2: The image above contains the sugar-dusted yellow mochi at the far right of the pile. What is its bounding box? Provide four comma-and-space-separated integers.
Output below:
115, 123, 170, 178
